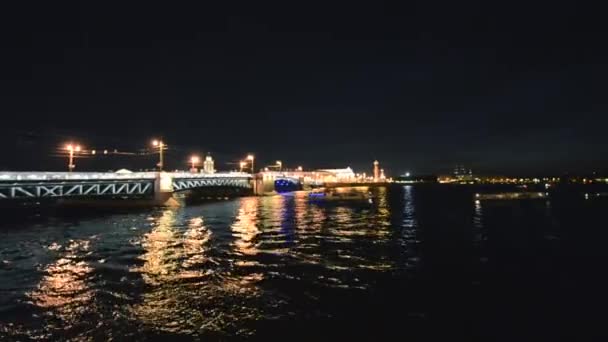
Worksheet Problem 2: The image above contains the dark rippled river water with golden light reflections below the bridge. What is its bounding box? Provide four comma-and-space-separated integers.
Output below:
0, 186, 608, 341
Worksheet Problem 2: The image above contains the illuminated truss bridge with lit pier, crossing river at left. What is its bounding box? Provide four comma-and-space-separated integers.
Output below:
0, 172, 253, 200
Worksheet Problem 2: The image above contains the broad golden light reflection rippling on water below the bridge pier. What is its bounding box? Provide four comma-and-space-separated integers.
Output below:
131, 209, 251, 334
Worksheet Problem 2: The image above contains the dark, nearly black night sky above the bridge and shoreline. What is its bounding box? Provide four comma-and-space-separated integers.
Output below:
0, 1, 608, 174
